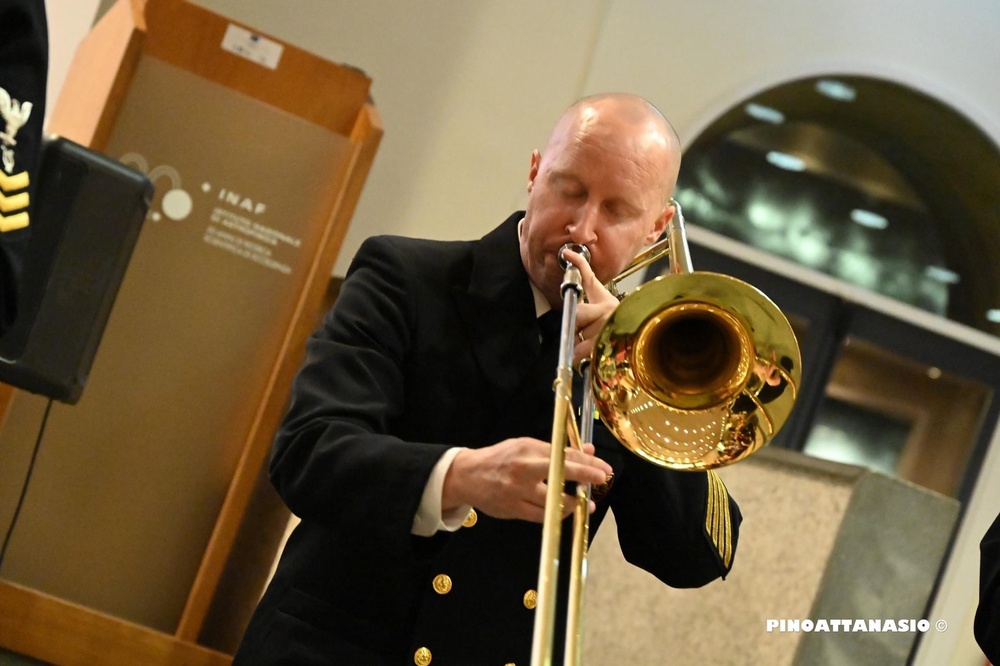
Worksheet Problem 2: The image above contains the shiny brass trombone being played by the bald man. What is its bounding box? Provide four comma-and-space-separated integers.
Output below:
531, 199, 801, 666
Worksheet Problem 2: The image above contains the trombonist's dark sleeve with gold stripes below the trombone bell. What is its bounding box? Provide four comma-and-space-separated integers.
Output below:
611, 458, 742, 588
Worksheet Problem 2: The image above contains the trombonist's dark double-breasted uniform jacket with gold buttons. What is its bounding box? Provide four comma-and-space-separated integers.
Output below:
235, 213, 740, 666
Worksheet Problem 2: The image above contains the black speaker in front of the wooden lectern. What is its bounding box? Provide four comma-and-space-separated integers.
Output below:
0, 137, 153, 404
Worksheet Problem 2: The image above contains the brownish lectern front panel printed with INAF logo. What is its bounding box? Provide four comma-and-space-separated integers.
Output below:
0, 56, 352, 632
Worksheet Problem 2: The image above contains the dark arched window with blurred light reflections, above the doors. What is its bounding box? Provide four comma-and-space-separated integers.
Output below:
677, 76, 1000, 336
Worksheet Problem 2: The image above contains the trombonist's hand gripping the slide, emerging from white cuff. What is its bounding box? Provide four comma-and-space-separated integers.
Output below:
441, 437, 612, 523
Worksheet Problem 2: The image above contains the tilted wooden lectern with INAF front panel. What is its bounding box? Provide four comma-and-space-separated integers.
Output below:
0, 0, 382, 666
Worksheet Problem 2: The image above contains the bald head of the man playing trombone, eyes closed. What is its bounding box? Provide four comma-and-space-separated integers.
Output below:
520, 94, 680, 307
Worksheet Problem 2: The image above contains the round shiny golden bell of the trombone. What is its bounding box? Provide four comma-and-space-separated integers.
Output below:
591, 272, 801, 470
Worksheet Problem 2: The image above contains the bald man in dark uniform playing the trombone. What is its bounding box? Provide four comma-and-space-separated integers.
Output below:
235, 94, 741, 666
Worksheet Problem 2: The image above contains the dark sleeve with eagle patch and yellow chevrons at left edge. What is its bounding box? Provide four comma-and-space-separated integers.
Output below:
0, 0, 48, 332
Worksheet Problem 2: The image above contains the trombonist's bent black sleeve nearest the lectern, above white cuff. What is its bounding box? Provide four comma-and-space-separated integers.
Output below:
270, 238, 450, 538
